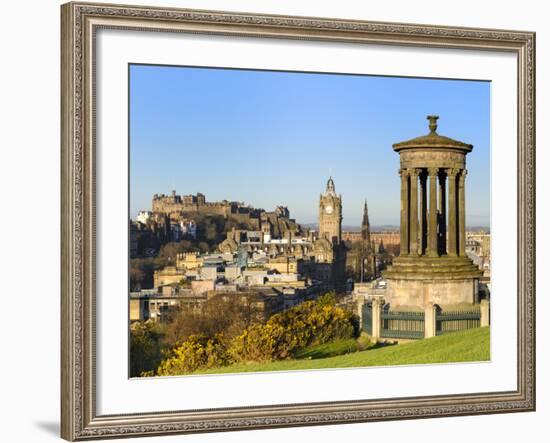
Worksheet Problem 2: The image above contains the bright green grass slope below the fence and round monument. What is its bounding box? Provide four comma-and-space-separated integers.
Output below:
197, 327, 490, 374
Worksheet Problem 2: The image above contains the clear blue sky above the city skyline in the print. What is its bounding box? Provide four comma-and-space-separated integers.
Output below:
130, 65, 490, 226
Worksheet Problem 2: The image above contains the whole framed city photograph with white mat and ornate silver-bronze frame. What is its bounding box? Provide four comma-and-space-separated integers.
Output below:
61, 2, 535, 440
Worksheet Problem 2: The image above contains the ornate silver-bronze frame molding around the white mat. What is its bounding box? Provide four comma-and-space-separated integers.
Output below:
61, 3, 535, 441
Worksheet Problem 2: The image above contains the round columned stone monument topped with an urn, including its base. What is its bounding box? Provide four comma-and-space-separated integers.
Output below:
383, 115, 481, 307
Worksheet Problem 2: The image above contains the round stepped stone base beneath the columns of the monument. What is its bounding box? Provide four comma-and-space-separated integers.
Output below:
383, 256, 482, 307
